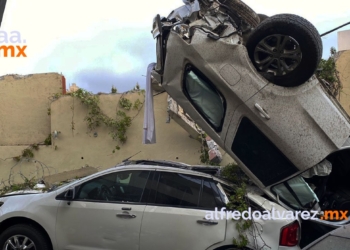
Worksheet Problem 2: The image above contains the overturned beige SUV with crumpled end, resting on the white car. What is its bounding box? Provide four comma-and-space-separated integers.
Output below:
151, 0, 350, 232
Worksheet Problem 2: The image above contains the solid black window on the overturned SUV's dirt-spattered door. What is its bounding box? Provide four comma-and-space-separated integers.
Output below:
231, 117, 298, 186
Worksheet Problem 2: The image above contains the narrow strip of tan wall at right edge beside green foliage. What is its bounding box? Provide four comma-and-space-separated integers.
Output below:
336, 50, 350, 115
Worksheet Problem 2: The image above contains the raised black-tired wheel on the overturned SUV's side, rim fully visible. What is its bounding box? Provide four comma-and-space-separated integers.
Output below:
246, 14, 322, 87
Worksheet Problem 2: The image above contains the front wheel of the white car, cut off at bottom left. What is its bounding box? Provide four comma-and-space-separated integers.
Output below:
0, 224, 51, 250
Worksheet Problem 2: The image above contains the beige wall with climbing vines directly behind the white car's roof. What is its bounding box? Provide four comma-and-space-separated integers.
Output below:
0, 90, 232, 186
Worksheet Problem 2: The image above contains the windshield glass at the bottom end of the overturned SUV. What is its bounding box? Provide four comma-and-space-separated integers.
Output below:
272, 176, 319, 209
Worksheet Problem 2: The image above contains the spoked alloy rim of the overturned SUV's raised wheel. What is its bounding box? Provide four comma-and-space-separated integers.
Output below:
254, 34, 302, 76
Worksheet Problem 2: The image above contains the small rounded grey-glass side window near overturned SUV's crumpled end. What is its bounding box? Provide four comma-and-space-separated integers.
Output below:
184, 65, 225, 132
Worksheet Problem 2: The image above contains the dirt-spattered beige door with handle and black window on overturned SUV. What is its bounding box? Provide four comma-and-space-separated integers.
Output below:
225, 79, 350, 188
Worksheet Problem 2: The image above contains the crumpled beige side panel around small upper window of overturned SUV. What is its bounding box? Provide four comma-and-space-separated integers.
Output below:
162, 31, 268, 150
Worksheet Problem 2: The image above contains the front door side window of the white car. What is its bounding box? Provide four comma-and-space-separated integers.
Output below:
77, 170, 150, 202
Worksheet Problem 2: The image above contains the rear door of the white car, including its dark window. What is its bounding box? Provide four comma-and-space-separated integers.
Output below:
140, 171, 226, 250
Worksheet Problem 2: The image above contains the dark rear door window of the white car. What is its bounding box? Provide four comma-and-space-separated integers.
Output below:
155, 173, 202, 207
